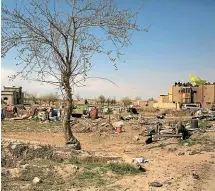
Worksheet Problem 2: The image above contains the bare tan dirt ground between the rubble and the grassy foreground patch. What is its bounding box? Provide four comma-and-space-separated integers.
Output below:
2, 118, 215, 191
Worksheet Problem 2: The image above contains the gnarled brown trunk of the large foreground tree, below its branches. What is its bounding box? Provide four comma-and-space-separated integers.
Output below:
63, 87, 81, 150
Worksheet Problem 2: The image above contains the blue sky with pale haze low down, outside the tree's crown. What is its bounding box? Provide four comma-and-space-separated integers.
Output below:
1, 0, 215, 99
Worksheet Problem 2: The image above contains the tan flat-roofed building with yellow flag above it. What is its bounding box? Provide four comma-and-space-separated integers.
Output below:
154, 83, 215, 109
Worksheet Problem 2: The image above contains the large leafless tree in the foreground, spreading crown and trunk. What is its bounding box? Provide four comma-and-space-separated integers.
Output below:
2, 0, 148, 148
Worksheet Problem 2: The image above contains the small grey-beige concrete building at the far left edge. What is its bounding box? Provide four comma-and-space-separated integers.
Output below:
1, 86, 24, 105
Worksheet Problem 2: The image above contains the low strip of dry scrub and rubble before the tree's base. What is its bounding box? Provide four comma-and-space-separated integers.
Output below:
1, 141, 121, 168
